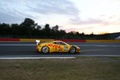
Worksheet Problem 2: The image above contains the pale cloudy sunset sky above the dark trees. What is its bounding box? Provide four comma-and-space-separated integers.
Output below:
0, 0, 120, 34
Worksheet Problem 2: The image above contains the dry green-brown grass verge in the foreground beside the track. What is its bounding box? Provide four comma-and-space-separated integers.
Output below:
0, 57, 120, 80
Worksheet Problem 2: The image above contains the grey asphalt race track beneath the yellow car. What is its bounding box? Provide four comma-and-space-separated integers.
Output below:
0, 42, 120, 57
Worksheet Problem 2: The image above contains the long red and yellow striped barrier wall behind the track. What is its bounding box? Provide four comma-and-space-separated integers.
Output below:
0, 38, 120, 42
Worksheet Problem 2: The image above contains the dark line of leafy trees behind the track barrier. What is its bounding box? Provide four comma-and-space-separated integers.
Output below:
0, 18, 110, 39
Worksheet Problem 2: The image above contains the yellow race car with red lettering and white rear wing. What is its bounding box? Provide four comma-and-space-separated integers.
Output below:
36, 40, 80, 53
